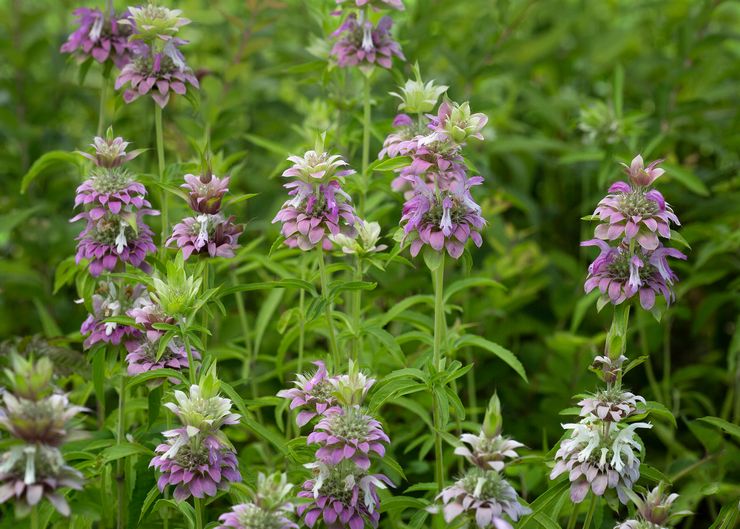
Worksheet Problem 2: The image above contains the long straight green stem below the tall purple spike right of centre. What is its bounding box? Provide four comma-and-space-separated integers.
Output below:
432, 252, 446, 492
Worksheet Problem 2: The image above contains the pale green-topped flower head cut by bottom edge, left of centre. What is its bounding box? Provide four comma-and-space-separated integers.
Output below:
218, 472, 298, 529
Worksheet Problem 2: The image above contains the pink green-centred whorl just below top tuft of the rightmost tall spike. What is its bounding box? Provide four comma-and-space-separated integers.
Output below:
594, 182, 681, 251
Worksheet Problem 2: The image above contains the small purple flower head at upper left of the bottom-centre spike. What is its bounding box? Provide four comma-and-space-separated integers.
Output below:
277, 361, 338, 426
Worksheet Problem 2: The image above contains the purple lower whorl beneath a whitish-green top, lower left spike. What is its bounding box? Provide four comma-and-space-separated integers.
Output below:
149, 428, 241, 501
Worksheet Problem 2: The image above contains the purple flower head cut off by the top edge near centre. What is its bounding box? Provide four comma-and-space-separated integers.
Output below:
331, 0, 406, 74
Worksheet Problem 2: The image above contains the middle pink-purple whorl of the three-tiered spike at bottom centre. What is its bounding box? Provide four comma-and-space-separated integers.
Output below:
307, 406, 390, 470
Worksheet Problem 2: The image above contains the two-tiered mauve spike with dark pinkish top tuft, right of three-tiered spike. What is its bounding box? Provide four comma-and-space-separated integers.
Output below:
167, 171, 243, 259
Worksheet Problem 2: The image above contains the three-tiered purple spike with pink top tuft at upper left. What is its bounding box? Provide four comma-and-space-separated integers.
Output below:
70, 129, 159, 277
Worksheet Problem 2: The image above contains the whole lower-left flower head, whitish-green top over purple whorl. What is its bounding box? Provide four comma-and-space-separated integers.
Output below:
149, 371, 241, 501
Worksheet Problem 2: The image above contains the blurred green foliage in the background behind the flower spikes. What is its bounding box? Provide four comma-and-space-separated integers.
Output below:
0, 0, 740, 527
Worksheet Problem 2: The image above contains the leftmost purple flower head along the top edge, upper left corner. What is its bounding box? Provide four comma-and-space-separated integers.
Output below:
60, 7, 136, 68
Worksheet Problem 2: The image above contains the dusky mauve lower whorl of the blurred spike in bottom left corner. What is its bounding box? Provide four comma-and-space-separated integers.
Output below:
0, 445, 83, 516
